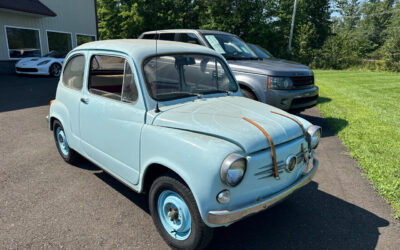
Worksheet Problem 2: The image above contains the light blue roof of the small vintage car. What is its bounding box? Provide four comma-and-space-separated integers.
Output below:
72, 39, 222, 62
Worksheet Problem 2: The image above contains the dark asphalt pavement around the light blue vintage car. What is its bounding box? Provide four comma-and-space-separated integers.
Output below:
0, 75, 400, 249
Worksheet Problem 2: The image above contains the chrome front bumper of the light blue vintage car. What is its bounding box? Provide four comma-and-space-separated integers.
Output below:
207, 158, 318, 225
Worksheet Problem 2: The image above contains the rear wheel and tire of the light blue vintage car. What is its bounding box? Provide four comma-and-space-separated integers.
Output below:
53, 120, 80, 164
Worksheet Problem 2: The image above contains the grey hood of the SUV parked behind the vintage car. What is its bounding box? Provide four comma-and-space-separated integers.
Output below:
228, 58, 313, 76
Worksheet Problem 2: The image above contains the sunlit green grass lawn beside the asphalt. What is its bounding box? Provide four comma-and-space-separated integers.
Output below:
314, 70, 400, 218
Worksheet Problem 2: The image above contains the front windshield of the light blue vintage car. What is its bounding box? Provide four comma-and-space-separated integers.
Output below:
143, 54, 238, 101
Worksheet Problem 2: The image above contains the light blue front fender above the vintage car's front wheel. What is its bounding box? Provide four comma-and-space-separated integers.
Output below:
139, 125, 243, 226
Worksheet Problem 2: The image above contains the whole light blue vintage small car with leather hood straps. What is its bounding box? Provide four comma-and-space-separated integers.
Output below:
47, 40, 321, 249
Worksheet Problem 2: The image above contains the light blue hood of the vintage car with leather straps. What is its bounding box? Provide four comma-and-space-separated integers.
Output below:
153, 96, 310, 153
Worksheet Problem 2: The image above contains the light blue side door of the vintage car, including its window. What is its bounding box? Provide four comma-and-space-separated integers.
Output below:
80, 52, 145, 185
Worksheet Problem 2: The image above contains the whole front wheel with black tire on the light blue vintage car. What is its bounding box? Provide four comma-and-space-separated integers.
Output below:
149, 176, 213, 249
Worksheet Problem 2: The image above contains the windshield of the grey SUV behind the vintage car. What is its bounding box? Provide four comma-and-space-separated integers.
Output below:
204, 34, 257, 60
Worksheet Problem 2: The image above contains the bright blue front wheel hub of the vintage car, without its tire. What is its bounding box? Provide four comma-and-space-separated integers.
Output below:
157, 190, 192, 240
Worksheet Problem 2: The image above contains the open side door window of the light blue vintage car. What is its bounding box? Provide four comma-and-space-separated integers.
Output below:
88, 55, 138, 102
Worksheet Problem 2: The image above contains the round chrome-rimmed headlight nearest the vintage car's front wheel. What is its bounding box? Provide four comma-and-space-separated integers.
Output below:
221, 154, 247, 187
